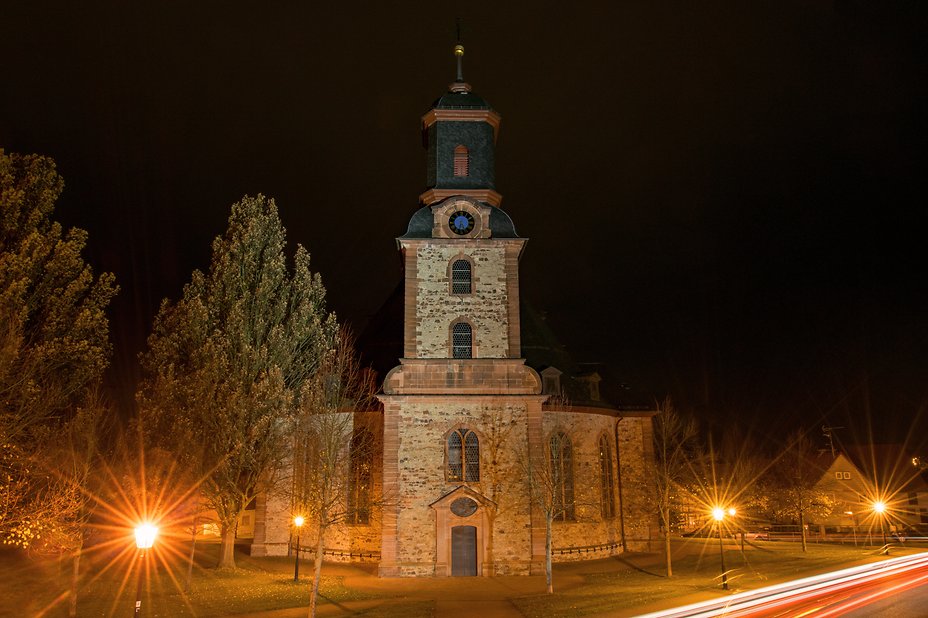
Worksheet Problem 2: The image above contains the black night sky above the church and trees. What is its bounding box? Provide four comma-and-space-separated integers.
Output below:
0, 0, 928, 441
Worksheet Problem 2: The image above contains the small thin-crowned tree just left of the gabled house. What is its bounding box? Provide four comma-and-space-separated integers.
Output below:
767, 431, 835, 551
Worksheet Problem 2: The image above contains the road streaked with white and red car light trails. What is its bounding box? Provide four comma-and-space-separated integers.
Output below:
643, 553, 928, 618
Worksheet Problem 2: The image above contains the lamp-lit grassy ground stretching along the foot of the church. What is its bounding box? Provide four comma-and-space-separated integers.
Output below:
0, 539, 924, 618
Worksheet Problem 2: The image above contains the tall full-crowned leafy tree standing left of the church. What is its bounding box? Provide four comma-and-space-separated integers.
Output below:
137, 195, 337, 568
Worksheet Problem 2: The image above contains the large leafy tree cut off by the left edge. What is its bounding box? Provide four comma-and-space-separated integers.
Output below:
0, 150, 117, 547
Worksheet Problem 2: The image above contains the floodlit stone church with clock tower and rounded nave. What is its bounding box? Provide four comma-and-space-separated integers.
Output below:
252, 45, 655, 577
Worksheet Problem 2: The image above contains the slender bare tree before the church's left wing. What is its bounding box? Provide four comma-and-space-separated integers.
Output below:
293, 329, 374, 617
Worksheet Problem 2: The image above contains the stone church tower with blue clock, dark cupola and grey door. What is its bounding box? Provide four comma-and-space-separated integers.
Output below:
380, 45, 544, 576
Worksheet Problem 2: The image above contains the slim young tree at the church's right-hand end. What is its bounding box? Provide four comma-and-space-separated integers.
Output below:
650, 397, 698, 577
